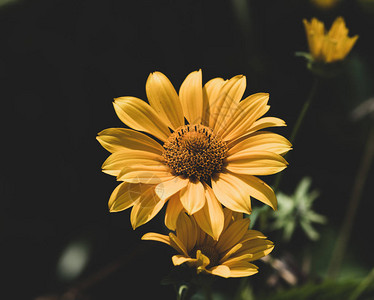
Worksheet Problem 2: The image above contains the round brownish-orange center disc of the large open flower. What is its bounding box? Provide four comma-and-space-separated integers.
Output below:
162, 124, 227, 182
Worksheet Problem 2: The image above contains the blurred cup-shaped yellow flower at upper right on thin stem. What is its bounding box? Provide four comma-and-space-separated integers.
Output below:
303, 17, 358, 63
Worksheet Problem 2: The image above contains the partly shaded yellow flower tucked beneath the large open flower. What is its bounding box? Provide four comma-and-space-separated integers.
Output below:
142, 208, 274, 277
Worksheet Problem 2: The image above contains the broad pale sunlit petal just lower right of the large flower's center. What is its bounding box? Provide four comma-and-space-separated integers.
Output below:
212, 173, 251, 214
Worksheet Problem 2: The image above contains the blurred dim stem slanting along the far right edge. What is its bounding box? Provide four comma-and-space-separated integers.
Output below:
327, 126, 374, 278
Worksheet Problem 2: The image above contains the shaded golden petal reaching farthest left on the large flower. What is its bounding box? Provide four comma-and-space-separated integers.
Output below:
96, 128, 164, 155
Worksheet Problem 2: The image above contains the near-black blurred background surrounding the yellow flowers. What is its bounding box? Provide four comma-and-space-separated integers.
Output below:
0, 0, 374, 300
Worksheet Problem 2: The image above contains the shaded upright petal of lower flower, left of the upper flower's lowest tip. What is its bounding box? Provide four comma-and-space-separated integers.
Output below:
176, 213, 197, 253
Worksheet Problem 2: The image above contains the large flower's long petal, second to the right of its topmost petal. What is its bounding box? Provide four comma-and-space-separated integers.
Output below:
212, 75, 247, 135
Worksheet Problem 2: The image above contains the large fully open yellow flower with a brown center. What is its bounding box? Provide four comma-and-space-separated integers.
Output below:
97, 70, 291, 239
